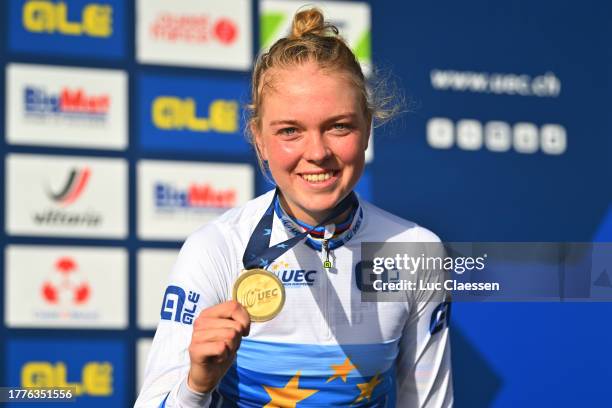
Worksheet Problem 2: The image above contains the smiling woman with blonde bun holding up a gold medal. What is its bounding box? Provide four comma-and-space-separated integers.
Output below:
136, 9, 453, 407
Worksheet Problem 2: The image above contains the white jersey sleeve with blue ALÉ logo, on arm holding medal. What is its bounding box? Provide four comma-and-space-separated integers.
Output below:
134, 224, 235, 408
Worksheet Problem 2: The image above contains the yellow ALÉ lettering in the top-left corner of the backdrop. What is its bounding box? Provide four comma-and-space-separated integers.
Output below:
23, 0, 113, 37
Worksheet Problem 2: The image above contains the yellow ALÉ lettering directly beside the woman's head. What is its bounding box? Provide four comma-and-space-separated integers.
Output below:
151, 96, 239, 133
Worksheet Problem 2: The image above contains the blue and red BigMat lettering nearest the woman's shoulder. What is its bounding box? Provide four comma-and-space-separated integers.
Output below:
155, 182, 237, 210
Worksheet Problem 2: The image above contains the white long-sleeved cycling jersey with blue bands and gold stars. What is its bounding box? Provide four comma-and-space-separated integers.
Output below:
135, 192, 453, 408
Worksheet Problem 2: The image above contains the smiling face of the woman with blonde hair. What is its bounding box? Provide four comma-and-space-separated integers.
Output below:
253, 62, 370, 224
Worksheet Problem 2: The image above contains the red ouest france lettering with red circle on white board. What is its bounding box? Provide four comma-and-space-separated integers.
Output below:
149, 12, 238, 45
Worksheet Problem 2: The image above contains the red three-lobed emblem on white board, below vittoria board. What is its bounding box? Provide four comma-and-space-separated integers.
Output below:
41, 257, 91, 305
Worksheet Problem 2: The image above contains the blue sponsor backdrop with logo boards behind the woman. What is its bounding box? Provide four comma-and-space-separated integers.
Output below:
0, 0, 612, 407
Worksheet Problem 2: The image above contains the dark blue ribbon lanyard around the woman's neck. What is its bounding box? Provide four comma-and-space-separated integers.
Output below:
242, 188, 357, 270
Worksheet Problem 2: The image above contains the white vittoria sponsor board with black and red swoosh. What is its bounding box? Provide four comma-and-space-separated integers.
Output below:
5, 154, 128, 238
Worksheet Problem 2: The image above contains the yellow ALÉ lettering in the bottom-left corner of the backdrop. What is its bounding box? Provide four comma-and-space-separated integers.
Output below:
21, 361, 113, 397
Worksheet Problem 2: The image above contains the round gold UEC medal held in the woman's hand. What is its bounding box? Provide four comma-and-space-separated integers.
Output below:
232, 269, 285, 322
